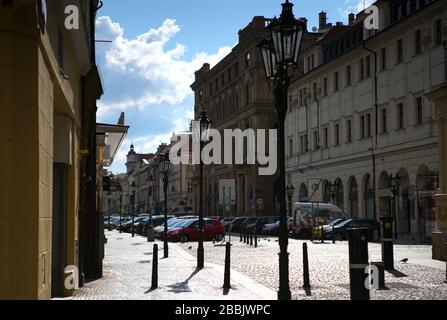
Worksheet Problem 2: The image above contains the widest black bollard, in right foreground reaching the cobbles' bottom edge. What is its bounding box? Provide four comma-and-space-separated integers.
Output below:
348, 228, 370, 300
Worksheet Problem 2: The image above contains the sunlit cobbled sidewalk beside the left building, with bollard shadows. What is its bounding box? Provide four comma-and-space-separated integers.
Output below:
70, 231, 276, 300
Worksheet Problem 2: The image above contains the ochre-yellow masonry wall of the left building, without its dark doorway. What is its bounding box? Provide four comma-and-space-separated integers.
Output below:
0, 0, 82, 300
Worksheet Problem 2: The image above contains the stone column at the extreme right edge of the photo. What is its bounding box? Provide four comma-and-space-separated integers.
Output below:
427, 87, 447, 260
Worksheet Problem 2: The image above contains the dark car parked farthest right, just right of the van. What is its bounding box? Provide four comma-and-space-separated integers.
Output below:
325, 219, 380, 241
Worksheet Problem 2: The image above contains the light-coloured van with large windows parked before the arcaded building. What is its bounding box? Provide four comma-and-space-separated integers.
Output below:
291, 202, 348, 238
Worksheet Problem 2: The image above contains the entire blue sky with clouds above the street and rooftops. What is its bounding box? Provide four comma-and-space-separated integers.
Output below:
96, 0, 373, 173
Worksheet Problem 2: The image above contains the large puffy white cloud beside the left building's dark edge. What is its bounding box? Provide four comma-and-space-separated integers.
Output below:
96, 16, 231, 117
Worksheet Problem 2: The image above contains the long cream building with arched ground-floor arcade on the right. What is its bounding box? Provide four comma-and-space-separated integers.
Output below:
285, 1, 447, 242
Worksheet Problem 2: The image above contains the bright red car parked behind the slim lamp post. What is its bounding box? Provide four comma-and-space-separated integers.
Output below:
168, 219, 225, 242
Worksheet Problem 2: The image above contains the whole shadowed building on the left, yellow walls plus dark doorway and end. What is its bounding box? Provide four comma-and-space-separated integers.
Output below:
0, 0, 102, 300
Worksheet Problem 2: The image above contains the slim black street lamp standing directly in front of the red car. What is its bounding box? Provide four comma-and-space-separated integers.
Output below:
194, 109, 211, 269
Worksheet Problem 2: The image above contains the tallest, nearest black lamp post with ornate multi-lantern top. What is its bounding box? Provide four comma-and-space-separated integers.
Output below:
259, 0, 306, 300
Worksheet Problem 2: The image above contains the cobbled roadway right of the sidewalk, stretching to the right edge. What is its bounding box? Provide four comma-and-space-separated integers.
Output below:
178, 236, 447, 300
